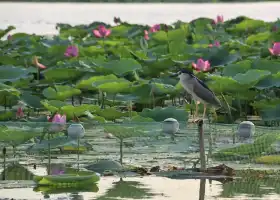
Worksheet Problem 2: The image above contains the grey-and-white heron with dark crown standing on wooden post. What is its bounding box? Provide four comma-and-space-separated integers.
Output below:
171, 69, 221, 121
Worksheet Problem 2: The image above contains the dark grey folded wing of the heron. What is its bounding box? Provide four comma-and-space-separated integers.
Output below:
193, 78, 221, 106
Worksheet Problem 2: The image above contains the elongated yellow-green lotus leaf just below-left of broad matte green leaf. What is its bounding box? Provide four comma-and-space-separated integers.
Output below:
76, 74, 119, 90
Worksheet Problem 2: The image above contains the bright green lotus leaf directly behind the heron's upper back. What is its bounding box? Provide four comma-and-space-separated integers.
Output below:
207, 75, 241, 93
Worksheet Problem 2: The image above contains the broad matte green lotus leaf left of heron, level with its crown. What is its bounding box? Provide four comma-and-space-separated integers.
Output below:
103, 58, 142, 75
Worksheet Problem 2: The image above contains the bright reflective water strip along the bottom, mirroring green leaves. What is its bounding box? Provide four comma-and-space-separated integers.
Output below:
0, 164, 280, 200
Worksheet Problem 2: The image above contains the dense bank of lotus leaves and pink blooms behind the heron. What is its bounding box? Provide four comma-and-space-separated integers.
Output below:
0, 16, 280, 122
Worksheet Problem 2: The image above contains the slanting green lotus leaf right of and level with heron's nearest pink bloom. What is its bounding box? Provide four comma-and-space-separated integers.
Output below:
223, 60, 252, 77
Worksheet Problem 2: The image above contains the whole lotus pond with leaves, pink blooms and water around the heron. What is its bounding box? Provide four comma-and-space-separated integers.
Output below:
0, 16, 280, 199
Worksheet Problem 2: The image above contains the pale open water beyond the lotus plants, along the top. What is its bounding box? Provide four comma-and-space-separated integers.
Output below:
0, 2, 280, 34
